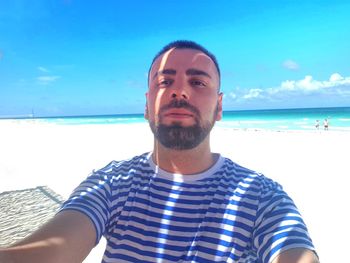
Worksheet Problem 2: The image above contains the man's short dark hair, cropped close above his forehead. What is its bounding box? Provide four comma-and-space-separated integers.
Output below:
148, 40, 220, 85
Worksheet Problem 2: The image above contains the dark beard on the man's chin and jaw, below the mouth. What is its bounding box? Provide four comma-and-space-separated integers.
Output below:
150, 122, 213, 150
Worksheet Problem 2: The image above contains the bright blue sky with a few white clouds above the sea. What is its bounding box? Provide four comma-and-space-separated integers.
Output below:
0, 0, 350, 117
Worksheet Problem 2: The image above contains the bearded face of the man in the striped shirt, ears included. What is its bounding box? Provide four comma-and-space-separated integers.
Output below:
145, 49, 222, 150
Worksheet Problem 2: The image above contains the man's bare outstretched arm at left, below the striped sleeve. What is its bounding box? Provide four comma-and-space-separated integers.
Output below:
0, 210, 96, 263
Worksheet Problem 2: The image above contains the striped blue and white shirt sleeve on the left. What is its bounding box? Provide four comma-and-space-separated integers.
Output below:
59, 171, 111, 245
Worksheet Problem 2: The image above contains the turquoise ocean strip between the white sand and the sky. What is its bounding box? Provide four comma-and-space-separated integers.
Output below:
2, 107, 350, 131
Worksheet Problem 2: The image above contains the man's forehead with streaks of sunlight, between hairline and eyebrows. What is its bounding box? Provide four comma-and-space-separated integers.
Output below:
150, 48, 218, 78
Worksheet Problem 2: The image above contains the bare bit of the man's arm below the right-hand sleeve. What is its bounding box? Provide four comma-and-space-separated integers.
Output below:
272, 248, 319, 263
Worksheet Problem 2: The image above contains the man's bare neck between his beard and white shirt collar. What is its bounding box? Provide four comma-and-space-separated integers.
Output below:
152, 136, 217, 175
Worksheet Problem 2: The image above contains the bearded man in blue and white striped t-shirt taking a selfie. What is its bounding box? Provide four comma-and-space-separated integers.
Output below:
0, 41, 318, 263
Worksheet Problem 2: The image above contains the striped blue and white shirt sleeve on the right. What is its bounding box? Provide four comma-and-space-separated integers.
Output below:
253, 178, 314, 263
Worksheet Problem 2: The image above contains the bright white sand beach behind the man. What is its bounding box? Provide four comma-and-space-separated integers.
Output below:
0, 120, 350, 262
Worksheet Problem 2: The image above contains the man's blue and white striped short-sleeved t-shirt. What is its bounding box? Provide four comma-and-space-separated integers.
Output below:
61, 153, 314, 263
